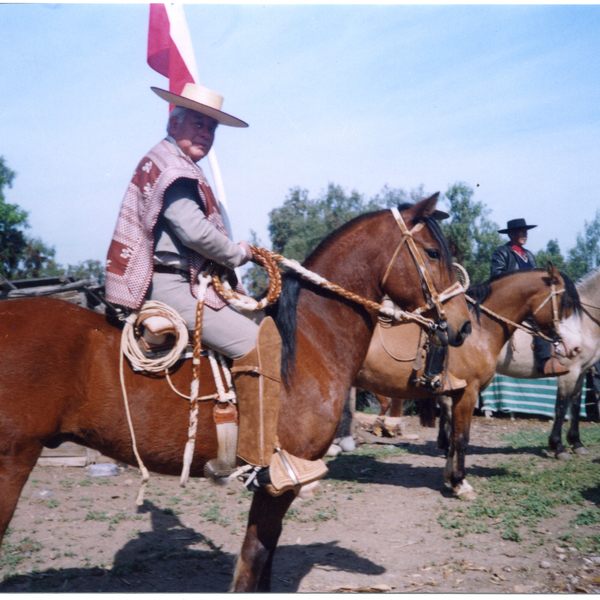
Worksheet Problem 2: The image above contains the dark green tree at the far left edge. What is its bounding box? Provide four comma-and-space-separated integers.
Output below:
0, 156, 29, 279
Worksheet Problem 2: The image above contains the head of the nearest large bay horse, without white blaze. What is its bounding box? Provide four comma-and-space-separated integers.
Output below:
381, 192, 471, 346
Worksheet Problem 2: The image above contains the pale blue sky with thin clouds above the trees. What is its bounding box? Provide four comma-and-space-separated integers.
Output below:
0, 4, 600, 264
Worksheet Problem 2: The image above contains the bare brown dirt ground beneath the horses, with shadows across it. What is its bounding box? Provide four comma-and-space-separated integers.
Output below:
0, 417, 600, 593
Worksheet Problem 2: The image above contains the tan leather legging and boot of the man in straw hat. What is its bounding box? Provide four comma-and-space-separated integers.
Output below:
231, 317, 327, 496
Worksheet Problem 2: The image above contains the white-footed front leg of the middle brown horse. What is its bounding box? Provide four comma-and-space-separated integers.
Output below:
448, 384, 478, 500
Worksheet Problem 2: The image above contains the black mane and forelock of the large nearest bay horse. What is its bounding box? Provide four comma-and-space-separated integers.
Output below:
266, 203, 452, 385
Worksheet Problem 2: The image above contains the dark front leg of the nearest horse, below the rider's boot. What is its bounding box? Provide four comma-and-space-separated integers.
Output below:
231, 488, 295, 592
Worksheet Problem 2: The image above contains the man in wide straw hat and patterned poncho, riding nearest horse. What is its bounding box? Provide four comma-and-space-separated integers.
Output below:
106, 83, 323, 492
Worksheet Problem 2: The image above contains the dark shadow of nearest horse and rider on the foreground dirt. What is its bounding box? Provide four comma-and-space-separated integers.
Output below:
0, 502, 385, 593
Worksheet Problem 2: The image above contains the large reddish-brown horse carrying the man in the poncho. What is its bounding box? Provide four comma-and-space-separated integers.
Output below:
0, 194, 470, 591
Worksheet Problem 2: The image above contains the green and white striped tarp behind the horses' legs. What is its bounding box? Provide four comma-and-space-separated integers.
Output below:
480, 374, 586, 418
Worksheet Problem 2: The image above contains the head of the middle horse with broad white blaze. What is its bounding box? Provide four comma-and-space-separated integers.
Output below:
531, 262, 582, 358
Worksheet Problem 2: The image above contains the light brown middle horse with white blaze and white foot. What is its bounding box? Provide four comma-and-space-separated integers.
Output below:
355, 265, 580, 499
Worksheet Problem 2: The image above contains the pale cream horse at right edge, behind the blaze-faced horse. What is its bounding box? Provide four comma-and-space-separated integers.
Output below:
496, 268, 600, 460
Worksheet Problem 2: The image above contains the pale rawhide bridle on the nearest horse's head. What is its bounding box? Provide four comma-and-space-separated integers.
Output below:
381, 207, 465, 338
